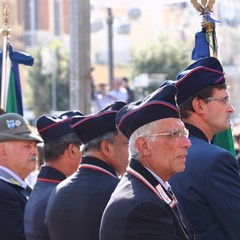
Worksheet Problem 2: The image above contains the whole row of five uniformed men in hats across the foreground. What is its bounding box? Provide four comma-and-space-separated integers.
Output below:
0, 57, 240, 240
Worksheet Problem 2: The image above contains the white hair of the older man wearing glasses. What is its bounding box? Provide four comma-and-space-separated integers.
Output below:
129, 120, 160, 160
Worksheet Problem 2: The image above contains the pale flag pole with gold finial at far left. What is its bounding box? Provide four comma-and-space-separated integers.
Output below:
1, 1, 11, 110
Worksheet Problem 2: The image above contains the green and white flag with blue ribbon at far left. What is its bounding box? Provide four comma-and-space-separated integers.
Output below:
0, 43, 34, 115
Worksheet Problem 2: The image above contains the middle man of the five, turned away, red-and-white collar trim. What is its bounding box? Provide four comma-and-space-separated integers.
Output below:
46, 102, 128, 240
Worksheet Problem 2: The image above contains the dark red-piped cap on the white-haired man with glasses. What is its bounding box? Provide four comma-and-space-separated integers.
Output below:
116, 85, 180, 139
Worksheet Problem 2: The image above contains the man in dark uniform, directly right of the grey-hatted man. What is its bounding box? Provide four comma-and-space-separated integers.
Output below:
24, 111, 82, 240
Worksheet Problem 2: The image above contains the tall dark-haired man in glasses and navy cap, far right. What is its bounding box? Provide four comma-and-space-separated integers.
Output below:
166, 57, 240, 240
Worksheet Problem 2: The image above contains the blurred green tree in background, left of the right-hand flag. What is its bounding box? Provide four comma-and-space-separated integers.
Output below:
130, 37, 191, 95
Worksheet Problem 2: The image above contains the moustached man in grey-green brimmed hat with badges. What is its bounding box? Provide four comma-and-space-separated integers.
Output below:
0, 113, 42, 240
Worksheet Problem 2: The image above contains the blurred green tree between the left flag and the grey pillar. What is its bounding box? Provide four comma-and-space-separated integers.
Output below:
27, 41, 69, 116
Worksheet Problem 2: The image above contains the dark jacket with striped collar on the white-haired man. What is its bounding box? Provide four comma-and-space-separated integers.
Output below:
100, 159, 197, 240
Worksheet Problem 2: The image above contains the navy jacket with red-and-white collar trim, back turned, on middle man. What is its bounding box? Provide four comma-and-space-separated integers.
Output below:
46, 157, 119, 240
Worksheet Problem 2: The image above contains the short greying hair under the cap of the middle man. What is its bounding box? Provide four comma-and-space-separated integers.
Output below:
82, 130, 118, 153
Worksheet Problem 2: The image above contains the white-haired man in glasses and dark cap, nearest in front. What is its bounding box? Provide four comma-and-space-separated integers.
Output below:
100, 86, 199, 240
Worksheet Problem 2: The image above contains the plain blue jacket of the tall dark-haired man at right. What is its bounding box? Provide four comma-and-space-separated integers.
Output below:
169, 124, 240, 240
